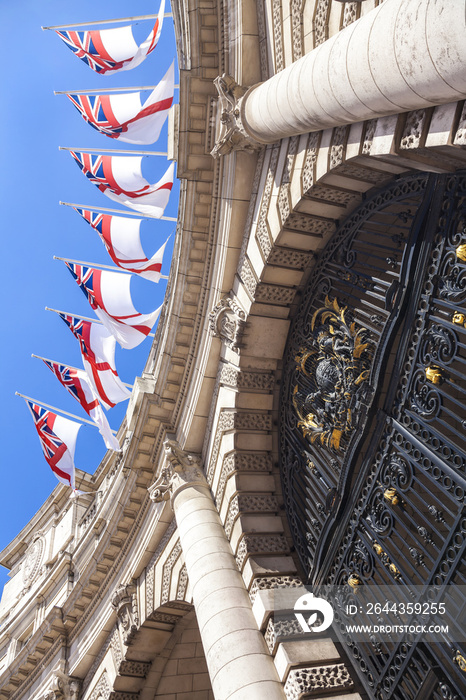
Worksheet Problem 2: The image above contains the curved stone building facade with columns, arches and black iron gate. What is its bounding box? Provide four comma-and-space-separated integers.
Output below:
0, 0, 466, 700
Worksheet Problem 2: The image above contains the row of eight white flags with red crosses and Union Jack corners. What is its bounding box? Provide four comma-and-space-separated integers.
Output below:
24, 5, 174, 495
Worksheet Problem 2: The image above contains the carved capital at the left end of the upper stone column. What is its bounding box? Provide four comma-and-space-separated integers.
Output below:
211, 74, 263, 158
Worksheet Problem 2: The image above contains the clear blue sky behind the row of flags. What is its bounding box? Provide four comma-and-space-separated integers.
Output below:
0, 0, 179, 588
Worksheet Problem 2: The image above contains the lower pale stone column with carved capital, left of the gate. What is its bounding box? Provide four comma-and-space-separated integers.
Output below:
149, 440, 285, 700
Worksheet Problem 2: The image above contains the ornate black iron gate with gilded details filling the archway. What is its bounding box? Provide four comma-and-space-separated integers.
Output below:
280, 173, 466, 700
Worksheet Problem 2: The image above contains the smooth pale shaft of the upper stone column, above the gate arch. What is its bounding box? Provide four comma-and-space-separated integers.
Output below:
224, 0, 466, 146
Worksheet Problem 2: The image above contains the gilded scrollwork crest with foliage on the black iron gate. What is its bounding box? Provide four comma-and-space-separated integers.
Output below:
292, 296, 375, 451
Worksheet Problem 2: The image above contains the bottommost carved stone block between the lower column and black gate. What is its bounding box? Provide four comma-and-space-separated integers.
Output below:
284, 664, 353, 700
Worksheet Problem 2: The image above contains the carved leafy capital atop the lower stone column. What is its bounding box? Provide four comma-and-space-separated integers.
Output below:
148, 440, 208, 503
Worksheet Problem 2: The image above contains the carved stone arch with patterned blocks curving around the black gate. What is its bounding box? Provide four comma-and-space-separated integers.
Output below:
203, 102, 466, 598
